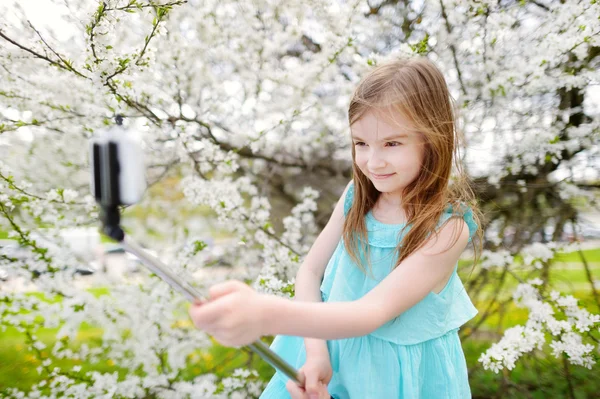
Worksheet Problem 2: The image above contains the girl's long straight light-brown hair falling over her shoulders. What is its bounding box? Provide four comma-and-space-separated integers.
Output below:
343, 57, 482, 271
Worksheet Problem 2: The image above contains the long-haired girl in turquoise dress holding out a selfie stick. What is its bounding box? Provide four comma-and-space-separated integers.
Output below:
190, 58, 481, 399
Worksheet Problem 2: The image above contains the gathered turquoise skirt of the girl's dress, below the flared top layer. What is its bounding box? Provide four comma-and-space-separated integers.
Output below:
260, 330, 471, 399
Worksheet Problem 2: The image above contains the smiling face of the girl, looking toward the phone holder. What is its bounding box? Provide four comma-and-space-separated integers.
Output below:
351, 112, 424, 199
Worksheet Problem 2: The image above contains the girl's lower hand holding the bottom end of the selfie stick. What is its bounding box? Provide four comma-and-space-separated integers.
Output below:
286, 352, 333, 399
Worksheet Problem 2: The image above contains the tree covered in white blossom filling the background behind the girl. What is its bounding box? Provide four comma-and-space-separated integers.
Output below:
0, 0, 600, 398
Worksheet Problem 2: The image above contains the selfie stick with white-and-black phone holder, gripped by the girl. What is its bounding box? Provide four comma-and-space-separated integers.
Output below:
90, 115, 304, 386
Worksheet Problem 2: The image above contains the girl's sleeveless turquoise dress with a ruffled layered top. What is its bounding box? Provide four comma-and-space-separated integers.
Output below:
260, 185, 477, 399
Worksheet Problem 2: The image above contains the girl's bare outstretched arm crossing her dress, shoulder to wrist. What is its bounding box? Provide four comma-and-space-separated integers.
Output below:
265, 219, 469, 339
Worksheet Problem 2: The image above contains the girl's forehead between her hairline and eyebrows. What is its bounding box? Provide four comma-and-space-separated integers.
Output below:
350, 110, 419, 137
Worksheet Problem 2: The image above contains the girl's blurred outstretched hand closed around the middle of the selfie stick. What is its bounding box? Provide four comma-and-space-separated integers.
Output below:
189, 280, 268, 347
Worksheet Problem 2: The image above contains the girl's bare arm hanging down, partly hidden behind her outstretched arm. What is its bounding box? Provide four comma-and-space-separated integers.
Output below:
295, 183, 350, 354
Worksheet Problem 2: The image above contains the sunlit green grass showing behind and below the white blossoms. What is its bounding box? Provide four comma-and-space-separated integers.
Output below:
0, 249, 600, 399
